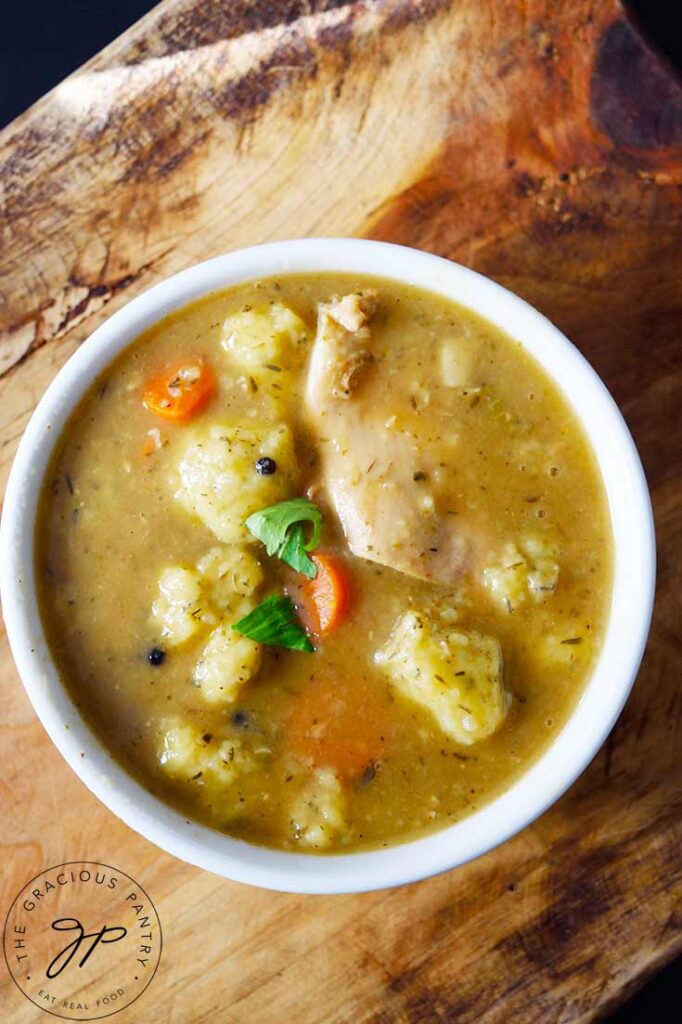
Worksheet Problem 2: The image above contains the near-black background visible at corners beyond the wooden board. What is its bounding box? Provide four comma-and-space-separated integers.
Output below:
0, 0, 682, 1024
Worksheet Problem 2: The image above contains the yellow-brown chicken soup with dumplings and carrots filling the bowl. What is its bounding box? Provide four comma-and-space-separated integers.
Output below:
37, 273, 612, 853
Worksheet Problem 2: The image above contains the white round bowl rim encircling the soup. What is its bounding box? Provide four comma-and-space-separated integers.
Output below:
0, 239, 655, 893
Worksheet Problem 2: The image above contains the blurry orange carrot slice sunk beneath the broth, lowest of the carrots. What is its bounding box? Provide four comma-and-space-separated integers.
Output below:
287, 676, 390, 778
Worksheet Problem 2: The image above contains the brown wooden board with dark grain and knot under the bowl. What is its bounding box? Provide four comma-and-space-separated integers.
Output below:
0, 0, 682, 1024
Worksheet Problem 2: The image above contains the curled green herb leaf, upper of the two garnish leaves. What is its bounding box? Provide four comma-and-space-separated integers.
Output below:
244, 498, 324, 580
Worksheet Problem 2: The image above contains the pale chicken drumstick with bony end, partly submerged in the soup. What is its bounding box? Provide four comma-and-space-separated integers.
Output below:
305, 290, 470, 584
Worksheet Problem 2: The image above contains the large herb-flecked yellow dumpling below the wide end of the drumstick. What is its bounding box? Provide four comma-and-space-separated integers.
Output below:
375, 611, 510, 746
